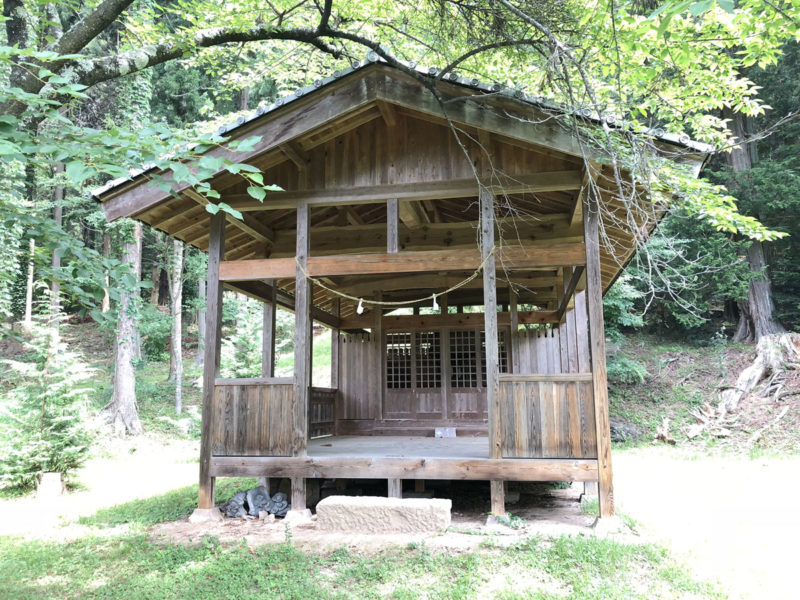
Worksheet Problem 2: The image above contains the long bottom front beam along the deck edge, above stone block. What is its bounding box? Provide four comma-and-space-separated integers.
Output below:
211, 456, 597, 481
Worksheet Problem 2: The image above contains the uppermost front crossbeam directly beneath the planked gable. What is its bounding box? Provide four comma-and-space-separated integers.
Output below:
222, 171, 582, 212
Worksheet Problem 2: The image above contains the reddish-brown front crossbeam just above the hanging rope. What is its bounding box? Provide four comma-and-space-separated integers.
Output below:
220, 243, 586, 281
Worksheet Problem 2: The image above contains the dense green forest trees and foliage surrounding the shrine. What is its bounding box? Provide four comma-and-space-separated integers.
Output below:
0, 0, 800, 489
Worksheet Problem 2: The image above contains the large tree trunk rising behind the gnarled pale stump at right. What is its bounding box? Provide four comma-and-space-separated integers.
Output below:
725, 110, 786, 342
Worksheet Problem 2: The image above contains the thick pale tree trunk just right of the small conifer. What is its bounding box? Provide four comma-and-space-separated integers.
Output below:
106, 223, 142, 435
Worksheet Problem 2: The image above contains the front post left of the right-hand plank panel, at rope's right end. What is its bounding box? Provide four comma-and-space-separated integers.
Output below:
479, 188, 506, 515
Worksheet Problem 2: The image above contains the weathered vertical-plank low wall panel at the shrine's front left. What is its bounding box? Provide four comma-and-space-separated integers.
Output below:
210, 380, 294, 456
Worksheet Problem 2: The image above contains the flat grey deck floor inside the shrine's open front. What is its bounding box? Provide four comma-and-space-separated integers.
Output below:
308, 435, 489, 458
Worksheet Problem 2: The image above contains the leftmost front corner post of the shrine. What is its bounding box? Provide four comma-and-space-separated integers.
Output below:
197, 211, 225, 509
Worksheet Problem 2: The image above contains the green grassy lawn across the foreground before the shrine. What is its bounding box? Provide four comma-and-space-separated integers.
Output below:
0, 480, 724, 600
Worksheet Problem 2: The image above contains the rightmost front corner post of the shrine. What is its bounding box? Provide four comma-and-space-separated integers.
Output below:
583, 193, 614, 517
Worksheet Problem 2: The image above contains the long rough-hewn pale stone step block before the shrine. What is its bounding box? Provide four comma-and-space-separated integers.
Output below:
317, 496, 453, 533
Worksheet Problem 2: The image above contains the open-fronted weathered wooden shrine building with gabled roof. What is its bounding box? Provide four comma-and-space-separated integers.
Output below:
95, 61, 705, 516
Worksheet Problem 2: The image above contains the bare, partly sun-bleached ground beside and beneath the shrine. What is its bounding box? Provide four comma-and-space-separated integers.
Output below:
0, 438, 800, 600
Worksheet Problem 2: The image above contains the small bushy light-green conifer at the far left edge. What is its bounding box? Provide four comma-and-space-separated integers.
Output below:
0, 323, 91, 489
